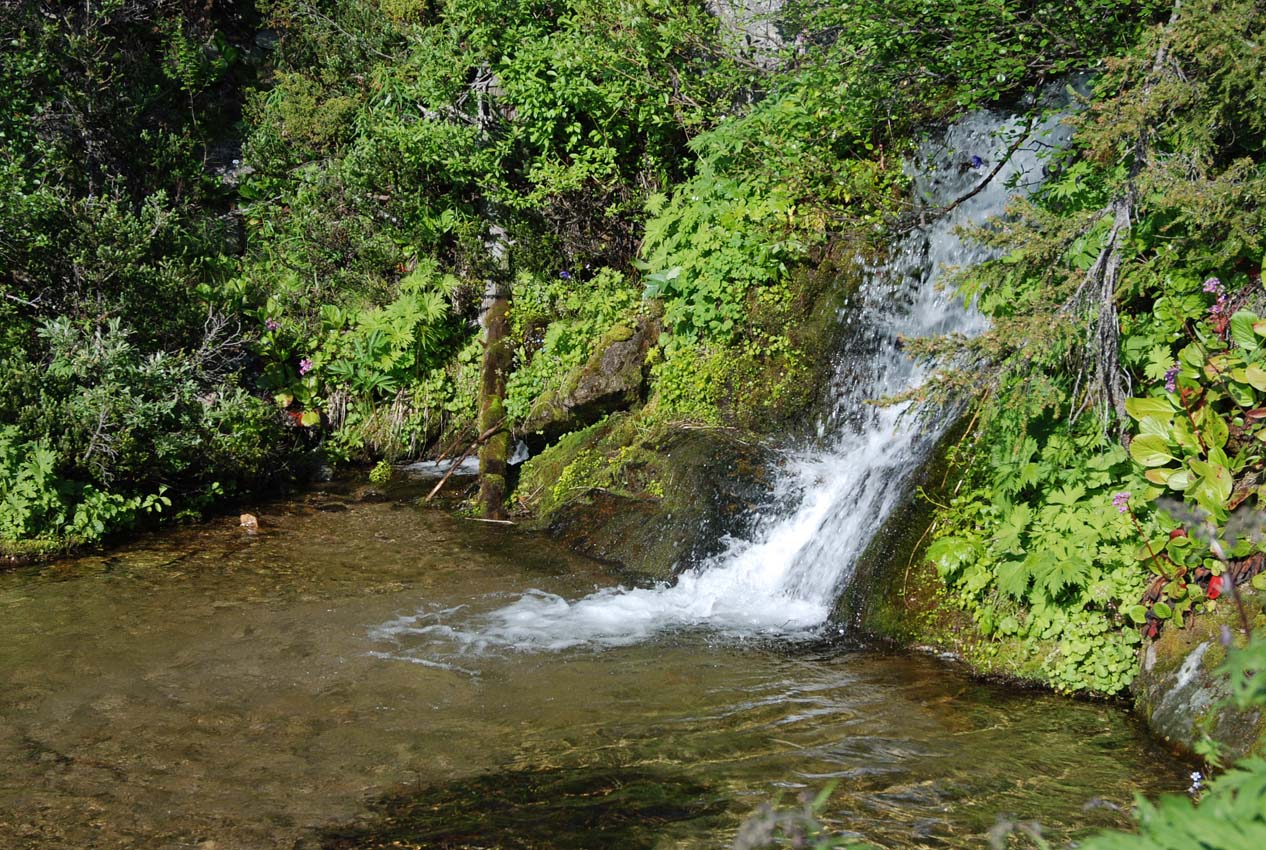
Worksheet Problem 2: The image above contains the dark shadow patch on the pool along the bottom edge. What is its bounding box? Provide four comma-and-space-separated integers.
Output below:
320, 766, 730, 850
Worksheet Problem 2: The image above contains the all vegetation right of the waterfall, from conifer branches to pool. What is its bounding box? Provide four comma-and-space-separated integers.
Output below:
923, 1, 1266, 693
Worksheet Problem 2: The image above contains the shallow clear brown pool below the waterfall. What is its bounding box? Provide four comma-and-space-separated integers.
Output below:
0, 492, 1190, 850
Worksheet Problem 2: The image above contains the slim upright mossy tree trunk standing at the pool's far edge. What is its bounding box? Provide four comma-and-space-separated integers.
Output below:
479, 279, 511, 519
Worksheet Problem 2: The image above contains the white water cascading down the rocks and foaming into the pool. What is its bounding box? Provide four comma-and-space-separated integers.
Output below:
375, 104, 1067, 663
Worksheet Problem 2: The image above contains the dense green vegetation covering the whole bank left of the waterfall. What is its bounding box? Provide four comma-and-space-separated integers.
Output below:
0, 0, 1155, 552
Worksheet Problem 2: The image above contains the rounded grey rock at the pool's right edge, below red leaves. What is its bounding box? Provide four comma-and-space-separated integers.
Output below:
1134, 600, 1266, 760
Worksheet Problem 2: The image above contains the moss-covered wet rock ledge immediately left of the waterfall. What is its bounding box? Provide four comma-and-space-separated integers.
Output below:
510, 255, 861, 583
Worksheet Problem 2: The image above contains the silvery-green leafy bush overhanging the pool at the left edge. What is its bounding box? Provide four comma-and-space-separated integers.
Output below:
0, 319, 286, 542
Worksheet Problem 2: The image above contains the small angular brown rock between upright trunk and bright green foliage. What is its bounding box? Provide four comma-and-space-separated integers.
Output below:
517, 322, 660, 454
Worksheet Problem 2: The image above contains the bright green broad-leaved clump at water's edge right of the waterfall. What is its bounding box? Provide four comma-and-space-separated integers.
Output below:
928, 428, 1156, 693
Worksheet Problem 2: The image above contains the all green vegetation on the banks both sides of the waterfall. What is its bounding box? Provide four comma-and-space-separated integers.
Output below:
0, 0, 1266, 709
